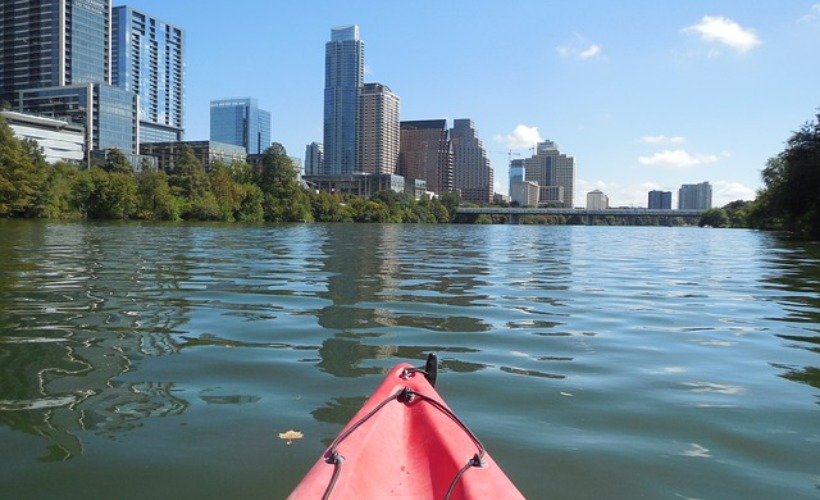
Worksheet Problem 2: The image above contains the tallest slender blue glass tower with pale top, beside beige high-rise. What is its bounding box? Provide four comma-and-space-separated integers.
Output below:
322, 25, 364, 175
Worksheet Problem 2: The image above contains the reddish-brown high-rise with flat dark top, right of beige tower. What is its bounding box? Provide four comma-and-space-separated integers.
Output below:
399, 120, 453, 194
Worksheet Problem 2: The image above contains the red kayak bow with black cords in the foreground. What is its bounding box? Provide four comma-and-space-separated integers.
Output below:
289, 355, 523, 500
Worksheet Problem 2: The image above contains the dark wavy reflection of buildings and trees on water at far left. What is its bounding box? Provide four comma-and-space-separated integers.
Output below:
0, 224, 188, 461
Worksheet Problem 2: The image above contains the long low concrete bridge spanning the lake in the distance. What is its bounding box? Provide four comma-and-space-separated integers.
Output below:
456, 207, 705, 225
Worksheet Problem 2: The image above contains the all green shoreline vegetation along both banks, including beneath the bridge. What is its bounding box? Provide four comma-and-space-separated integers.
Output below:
0, 114, 820, 240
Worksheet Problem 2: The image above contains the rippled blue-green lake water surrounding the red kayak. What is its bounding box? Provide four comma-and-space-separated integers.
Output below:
0, 221, 820, 500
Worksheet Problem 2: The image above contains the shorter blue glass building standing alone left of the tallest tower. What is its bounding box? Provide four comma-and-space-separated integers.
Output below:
211, 97, 271, 154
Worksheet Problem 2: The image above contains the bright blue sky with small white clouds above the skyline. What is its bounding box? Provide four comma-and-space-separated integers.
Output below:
123, 0, 820, 207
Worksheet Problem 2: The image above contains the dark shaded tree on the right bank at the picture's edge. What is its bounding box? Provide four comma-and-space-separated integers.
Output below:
749, 114, 820, 240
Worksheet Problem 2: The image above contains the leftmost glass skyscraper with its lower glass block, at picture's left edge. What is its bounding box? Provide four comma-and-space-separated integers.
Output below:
0, 0, 139, 155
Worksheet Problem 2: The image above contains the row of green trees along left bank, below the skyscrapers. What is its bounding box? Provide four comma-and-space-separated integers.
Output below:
0, 116, 459, 223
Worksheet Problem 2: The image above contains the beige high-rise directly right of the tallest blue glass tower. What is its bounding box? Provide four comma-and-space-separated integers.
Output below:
356, 83, 401, 174
